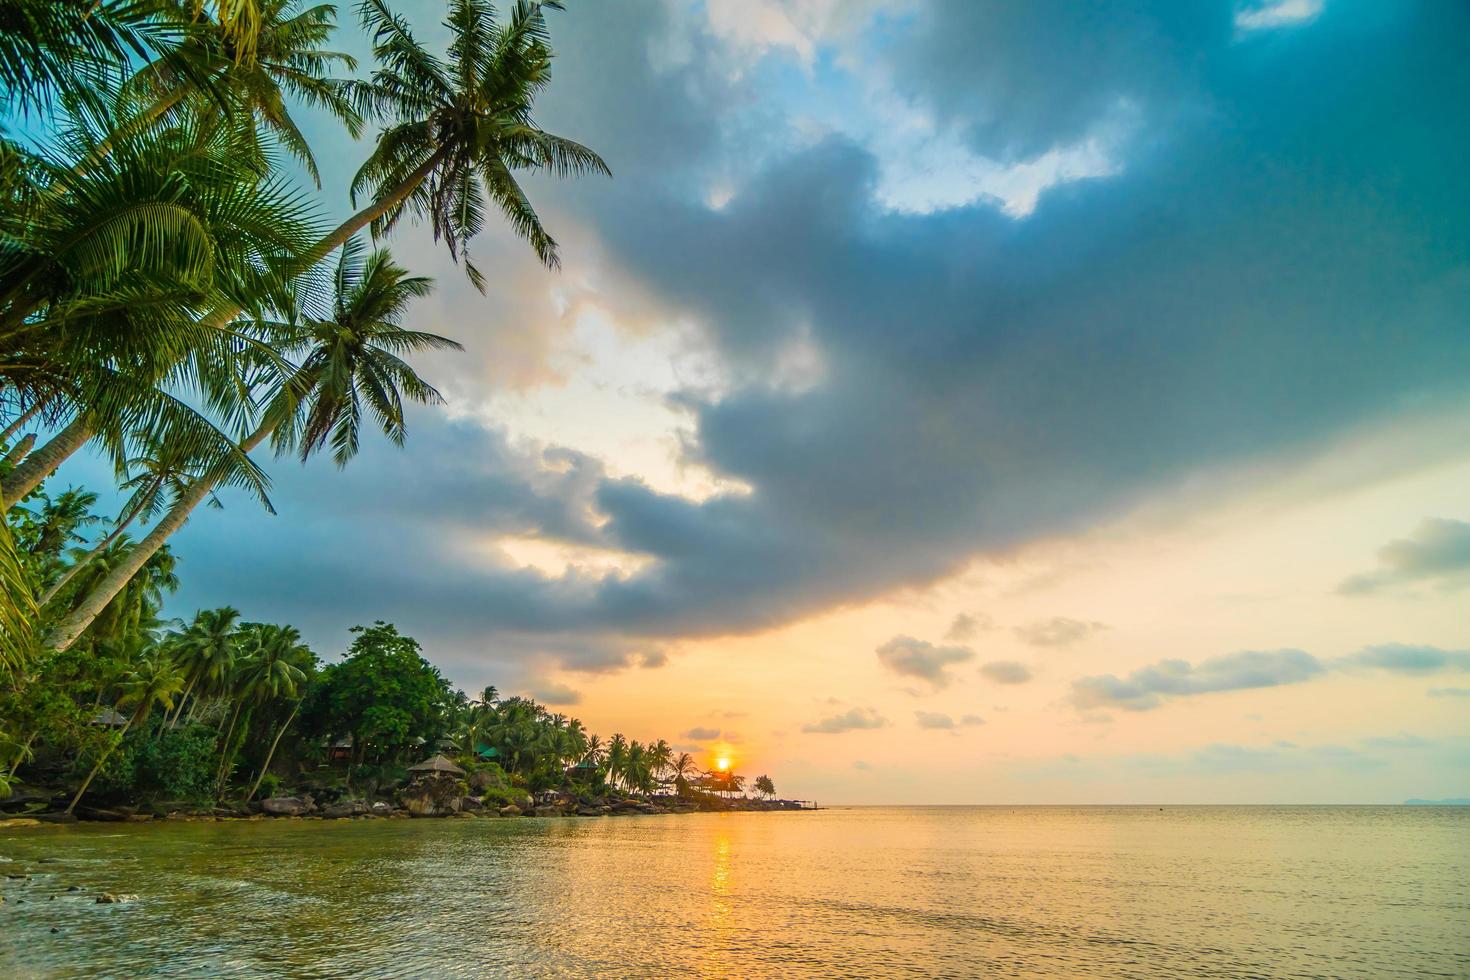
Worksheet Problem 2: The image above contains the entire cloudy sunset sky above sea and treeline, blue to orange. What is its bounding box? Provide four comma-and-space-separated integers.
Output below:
63, 0, 1470, 804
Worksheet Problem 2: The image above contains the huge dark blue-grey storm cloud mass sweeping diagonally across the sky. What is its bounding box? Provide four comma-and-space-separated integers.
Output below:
158, 0, 1470, 681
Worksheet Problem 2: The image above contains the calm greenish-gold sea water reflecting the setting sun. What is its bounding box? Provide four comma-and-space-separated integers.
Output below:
0, 807, 1470, 977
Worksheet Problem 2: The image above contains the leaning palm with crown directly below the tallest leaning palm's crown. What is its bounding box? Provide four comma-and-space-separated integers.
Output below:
47, 242, 460, 649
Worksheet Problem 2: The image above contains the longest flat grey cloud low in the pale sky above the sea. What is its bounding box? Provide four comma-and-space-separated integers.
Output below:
1072, 649, 1326, 711
